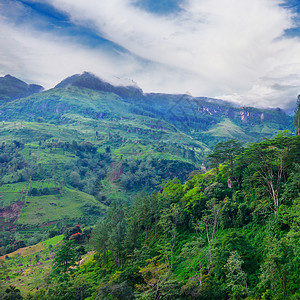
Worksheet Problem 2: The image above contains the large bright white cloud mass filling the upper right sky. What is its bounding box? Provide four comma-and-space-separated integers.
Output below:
44, 0, 300, 106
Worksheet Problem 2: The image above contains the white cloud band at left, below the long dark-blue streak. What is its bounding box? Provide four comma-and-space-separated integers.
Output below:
0, 14, 146, 88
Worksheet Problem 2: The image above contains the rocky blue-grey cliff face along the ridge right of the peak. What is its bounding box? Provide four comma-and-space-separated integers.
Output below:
142, 93, 291, 130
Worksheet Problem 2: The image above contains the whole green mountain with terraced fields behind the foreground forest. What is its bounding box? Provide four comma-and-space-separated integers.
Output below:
0, 73, 292, 260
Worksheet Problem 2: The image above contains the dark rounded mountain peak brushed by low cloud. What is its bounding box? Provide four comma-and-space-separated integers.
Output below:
55, 72, 143, 99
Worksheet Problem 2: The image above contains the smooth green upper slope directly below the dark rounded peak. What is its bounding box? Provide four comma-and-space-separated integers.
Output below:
0, 86, 133, 123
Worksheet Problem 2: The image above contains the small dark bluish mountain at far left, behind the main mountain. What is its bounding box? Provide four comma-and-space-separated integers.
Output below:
0, 75, 44, 105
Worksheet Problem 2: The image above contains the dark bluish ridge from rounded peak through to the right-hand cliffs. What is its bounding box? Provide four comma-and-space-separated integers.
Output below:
56, 72, 292, 146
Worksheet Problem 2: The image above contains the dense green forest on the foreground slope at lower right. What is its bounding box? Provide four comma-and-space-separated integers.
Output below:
1, 132, 300, 299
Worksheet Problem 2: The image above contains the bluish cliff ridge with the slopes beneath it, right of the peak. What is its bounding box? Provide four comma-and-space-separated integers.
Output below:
141, 94, 293, 146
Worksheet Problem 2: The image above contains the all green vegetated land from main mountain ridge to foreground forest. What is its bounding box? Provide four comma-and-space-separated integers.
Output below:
0, 73, 300, 299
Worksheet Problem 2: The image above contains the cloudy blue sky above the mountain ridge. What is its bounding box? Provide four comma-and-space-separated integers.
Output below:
0, 0, 300, 109
